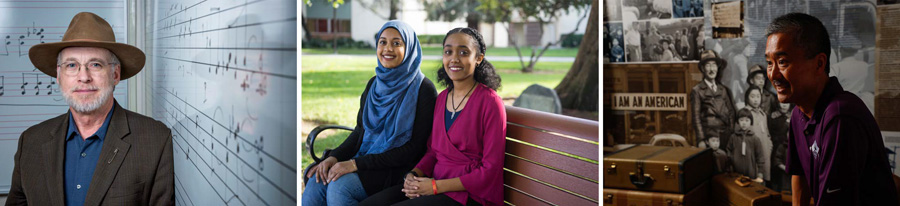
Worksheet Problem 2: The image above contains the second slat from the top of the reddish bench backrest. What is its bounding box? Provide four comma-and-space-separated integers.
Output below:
506, 124, 600, 161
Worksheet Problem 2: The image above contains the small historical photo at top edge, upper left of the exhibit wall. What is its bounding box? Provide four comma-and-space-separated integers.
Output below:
622, 0, 672, 20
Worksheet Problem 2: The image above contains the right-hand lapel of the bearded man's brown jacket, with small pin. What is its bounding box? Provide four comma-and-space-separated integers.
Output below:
84, 103, 131, 205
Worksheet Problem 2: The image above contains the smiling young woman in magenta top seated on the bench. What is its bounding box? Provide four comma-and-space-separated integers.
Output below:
361, 28, 506, 205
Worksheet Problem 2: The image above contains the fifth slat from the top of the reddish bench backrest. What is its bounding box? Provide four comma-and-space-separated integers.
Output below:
503, 171, 598, 205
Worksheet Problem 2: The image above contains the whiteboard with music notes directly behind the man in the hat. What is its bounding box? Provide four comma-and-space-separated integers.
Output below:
0, 0, 128, 194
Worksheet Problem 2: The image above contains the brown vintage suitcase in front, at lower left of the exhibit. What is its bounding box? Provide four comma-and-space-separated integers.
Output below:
603, 145, 715, 194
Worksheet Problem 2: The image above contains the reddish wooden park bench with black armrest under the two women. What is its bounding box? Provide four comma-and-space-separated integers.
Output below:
303, 106, 600, 205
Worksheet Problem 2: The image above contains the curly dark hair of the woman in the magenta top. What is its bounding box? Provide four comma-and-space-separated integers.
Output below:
437, 27, 500, 91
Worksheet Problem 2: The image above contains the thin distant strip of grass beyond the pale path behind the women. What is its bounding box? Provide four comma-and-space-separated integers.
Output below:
301, 46, 578, 57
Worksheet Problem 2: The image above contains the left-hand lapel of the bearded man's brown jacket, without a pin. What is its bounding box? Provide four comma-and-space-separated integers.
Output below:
42, 114, 69, 206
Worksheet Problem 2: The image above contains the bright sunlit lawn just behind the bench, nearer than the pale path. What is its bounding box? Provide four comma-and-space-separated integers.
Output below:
301, 55, 572, 171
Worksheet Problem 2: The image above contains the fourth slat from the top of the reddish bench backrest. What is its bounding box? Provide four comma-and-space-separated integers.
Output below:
504, 156, 600, 200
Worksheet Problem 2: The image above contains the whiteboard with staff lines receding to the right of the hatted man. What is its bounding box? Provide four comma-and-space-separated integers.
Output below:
148, 0, 297, 205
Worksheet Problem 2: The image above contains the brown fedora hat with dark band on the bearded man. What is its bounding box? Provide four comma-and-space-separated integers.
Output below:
28, 12, 147, 80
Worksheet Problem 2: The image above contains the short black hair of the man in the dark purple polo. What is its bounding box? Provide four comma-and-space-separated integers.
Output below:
766, 13, 831, 74
